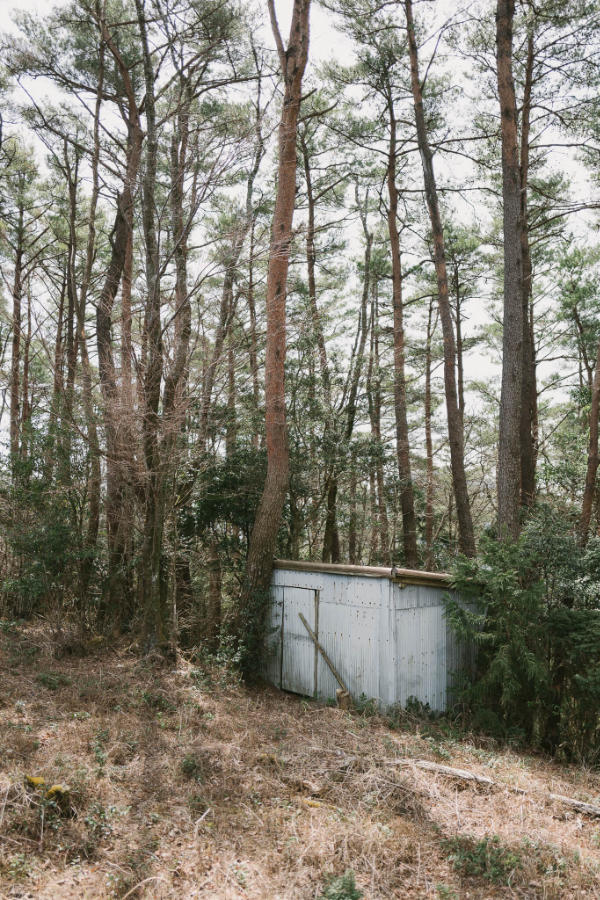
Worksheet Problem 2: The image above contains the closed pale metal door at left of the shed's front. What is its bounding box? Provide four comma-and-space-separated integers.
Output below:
281, 585, 319, 696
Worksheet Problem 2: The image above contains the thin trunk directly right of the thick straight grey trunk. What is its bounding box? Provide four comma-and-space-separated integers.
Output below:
520, 30, 537, 507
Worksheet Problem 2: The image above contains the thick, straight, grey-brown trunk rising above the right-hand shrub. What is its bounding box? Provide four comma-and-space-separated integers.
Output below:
496, 0, 523, 539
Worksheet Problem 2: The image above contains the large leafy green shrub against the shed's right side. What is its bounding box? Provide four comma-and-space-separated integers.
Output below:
447, 512, 600, 763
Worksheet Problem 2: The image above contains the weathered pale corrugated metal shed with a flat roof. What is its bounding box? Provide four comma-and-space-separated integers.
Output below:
265, 560, 464, 712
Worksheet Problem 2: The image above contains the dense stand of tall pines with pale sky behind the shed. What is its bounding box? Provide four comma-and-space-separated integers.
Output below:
0, 0, 600, 742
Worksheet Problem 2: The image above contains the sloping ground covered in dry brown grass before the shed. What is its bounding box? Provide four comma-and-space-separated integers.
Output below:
0, 621, 600, 900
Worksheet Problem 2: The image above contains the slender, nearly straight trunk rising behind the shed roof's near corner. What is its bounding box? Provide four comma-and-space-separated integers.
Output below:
387, 88, 419, 569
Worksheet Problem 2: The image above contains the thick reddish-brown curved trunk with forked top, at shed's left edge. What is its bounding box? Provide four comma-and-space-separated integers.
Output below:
243, 0, 310, 659
